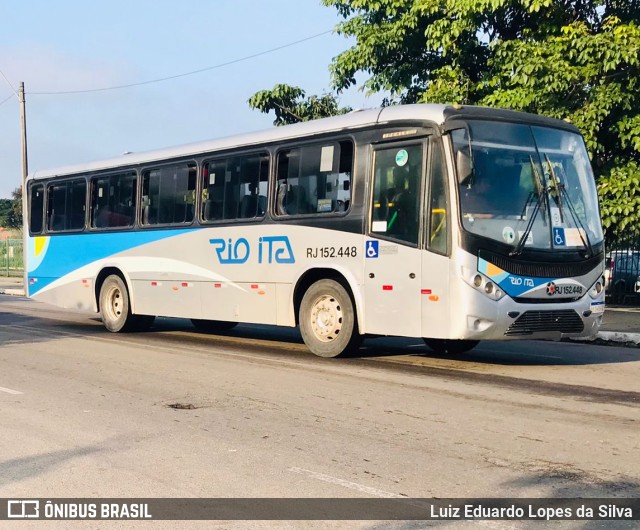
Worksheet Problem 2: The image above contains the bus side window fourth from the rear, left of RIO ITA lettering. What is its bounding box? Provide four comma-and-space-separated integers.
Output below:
142, 163, 197, 225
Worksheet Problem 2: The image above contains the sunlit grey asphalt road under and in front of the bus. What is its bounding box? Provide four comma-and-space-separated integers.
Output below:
0, 296, 640, 528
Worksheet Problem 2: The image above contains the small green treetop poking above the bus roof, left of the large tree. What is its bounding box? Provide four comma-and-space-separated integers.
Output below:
249, 84, 352, 125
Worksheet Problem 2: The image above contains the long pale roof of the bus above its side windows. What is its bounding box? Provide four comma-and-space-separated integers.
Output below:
29, 103, 571, 180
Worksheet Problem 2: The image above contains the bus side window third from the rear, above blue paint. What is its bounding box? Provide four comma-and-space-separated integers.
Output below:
91, 172, 136, 228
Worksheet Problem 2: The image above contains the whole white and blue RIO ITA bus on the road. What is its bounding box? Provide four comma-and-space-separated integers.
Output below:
25, 104, 604, 357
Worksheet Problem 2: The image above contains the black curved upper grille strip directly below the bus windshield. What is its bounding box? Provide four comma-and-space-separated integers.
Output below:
478, 250, 604, 278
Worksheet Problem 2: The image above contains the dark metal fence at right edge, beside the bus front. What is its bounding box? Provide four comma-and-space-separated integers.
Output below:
605, 230, 640, 306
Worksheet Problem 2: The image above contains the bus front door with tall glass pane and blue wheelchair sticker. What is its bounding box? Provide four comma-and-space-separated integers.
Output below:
364, 142, 425, 337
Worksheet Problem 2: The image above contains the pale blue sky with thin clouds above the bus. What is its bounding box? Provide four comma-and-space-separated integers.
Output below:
0, 0, 382, 198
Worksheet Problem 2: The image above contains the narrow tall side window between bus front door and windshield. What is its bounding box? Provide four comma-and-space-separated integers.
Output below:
427, 140, 449, 254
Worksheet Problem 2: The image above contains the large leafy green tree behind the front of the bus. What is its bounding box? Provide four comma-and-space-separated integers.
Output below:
248, 0, 640, 242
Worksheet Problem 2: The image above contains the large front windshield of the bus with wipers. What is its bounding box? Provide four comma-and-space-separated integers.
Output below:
451, 121, 603, 250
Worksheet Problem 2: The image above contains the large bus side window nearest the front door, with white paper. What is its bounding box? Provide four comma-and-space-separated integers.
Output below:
276, 141, 353, 215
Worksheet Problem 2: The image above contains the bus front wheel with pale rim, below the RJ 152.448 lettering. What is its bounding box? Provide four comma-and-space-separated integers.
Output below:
298, 280, 361, 357
